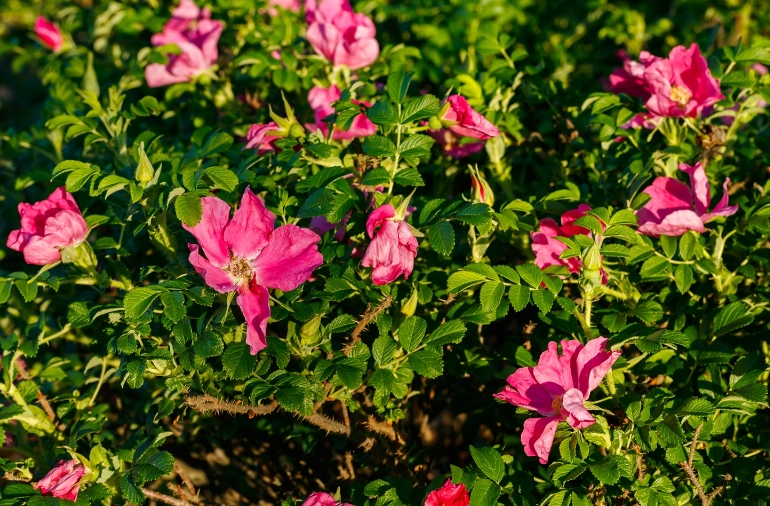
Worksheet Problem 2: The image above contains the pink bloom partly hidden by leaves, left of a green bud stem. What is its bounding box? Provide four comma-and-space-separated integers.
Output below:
531, 204, 591, 274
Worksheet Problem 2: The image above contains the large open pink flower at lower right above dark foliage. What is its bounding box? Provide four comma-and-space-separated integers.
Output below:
494, 337, 620, 464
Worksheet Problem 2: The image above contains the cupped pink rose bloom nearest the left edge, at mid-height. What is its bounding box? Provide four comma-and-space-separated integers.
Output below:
6, 187, 88, 265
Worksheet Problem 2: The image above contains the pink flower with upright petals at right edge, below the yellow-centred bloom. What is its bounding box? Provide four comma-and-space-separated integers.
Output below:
636, 163, 738, 237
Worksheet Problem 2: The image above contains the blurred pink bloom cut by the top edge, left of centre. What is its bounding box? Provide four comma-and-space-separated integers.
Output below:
305, 0, 380, 70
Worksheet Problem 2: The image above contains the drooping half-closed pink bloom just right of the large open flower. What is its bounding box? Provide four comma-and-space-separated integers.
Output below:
361, 204, 417, 285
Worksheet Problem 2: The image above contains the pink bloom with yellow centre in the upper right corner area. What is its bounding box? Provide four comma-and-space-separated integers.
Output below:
644, 43, 725, 118
